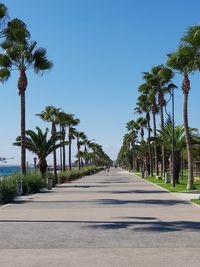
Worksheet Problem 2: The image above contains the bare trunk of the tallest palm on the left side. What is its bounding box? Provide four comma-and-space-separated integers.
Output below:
20, 90, 26, 175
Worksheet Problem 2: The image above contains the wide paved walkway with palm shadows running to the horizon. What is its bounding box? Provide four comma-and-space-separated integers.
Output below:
0, 169, 200, 267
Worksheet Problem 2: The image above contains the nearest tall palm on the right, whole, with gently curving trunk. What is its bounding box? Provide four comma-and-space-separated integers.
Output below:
167, 46, 198, 189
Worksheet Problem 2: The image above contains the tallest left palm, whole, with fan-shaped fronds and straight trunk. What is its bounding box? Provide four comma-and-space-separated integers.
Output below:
0, 31, 53, 175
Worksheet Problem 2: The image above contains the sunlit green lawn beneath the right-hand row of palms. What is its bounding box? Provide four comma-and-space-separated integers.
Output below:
135, 173, 200, 192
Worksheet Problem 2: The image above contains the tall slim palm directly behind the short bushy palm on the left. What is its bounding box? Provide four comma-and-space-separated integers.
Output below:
36, 106, 60, 178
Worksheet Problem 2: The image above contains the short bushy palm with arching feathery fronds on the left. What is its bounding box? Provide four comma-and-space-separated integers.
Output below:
13, 127, 62, 178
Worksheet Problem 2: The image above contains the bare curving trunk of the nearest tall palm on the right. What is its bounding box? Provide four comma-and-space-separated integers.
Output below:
183, 91, 193, 190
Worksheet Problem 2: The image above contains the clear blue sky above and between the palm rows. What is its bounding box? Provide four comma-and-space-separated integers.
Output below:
0, 0, 200, 164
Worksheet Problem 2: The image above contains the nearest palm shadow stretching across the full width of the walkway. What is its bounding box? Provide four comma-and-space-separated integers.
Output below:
0, 220, 200, 233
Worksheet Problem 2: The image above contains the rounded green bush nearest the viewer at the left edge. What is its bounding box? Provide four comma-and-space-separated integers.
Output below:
0, 177, 18, 204
